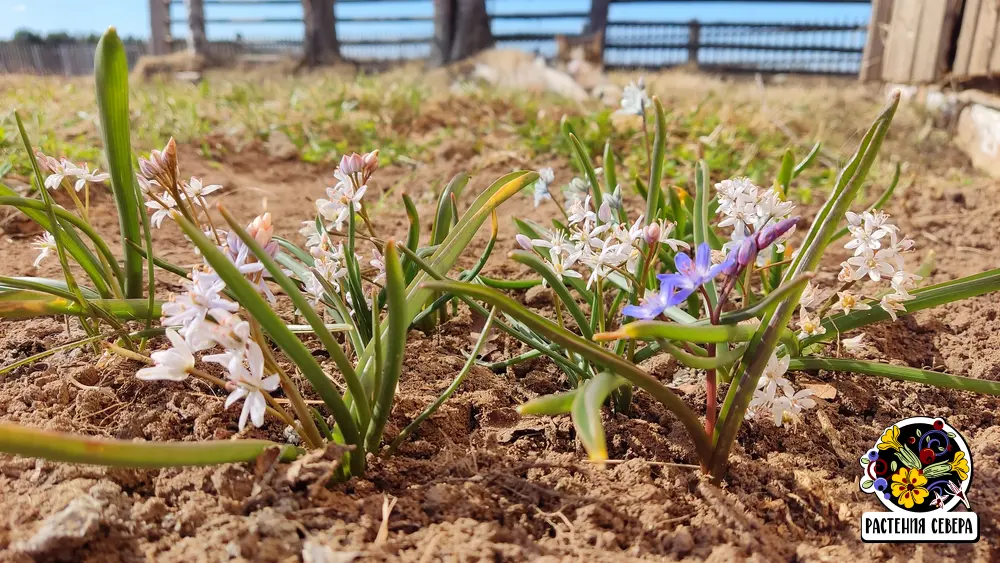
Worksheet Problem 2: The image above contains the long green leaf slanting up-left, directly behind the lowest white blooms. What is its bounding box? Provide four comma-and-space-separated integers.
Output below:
175, 216, 365, 477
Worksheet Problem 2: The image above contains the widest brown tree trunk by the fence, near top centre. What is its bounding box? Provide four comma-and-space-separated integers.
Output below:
431, 0, 494, 66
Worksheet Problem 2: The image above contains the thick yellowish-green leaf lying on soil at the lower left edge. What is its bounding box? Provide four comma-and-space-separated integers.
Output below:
0, 422, 297, 468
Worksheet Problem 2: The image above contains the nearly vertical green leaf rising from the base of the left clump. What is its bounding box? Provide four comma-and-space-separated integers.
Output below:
366, 239, 410, 452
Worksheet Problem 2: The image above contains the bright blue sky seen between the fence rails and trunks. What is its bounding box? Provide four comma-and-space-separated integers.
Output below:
0, 0, 870, 38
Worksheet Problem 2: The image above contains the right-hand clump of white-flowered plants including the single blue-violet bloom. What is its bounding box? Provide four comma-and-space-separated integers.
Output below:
426, 85, 1000, 479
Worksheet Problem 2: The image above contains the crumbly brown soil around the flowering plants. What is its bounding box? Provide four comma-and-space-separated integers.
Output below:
0, 76, 1000, 562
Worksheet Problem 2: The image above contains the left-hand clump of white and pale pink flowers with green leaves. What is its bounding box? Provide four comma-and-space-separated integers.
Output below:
0, 30, 538, 479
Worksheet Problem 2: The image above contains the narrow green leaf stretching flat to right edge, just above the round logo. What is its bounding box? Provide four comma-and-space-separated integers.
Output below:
788, 357, 1000, 395
